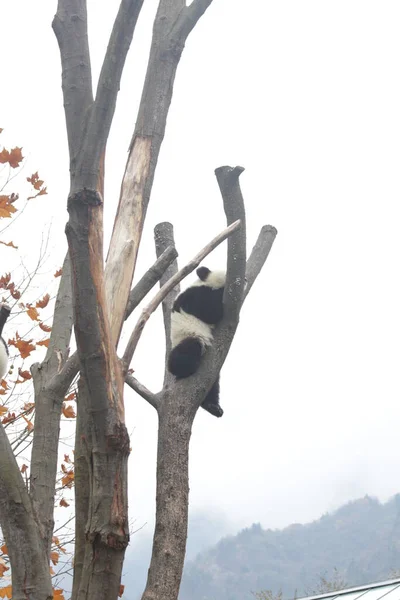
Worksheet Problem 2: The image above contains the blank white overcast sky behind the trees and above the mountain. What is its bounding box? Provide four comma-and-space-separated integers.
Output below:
0, 0, 400, 540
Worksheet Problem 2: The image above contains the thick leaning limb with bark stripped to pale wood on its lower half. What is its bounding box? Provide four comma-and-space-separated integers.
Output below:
106, 0, 216, 345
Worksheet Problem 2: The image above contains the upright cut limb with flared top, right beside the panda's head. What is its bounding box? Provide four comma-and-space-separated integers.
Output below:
215, 166, 246, 321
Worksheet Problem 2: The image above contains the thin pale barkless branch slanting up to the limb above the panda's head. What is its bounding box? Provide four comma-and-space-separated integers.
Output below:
122, 221, 241, 371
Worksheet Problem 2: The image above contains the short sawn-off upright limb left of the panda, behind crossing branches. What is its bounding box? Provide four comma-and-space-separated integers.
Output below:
154, 222, 180, 358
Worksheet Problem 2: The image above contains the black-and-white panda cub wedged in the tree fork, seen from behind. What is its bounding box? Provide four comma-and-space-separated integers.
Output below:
168, 267, 226, 417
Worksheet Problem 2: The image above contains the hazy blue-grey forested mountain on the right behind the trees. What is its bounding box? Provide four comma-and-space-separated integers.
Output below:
179, 494, 400, 600
